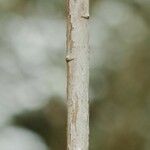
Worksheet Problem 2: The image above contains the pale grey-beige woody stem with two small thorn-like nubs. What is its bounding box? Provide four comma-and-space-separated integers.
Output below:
66, 0, 89, 150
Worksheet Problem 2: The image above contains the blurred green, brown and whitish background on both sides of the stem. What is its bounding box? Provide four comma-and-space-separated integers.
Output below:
0, 0, 150, 150
